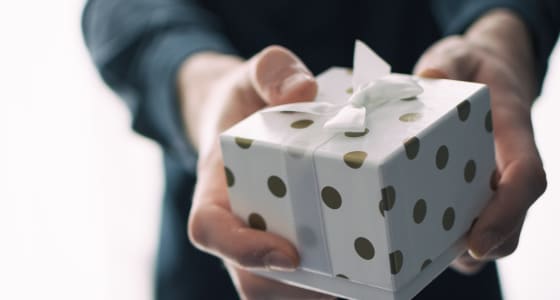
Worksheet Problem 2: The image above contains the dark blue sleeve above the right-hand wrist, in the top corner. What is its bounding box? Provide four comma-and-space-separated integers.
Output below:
432, 0, 557, 88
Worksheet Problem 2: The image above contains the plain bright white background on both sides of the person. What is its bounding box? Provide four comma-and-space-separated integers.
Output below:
0, 0, 560, 300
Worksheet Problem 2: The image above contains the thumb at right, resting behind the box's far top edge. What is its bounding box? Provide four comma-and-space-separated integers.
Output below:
414, 37, 479, 80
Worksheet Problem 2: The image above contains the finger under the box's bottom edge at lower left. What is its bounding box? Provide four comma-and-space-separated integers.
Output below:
227, 265, 334, 300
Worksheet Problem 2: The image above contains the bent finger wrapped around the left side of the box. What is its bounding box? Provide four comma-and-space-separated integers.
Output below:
188, 146, 299, 270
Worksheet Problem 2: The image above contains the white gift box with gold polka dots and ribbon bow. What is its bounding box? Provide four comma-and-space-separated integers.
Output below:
221, 41, 495, 300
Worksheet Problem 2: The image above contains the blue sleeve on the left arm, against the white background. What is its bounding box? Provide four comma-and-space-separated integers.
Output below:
82, 0, 235, 172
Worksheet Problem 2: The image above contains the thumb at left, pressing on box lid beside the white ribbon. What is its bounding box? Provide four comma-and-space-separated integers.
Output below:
249, 46, 318, 105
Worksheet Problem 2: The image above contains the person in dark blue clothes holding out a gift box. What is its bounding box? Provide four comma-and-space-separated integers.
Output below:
83, 0, 555, 299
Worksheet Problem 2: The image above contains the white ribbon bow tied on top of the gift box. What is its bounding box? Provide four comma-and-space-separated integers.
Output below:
263, 40, 424, 132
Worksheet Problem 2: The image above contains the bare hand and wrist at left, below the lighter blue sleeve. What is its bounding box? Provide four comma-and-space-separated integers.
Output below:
179, 46, 331, 299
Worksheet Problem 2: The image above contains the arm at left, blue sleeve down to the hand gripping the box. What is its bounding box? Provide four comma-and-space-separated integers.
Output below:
83, 0, 330, 299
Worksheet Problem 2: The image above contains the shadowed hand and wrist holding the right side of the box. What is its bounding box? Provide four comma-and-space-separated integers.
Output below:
415, 10, 546, 273
